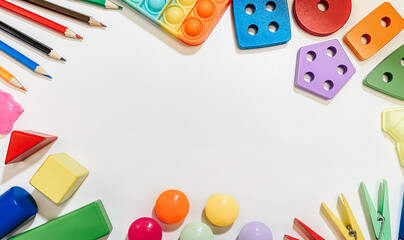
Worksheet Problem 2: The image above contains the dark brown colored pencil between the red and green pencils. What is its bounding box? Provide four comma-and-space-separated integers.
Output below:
22, 0, 106, 27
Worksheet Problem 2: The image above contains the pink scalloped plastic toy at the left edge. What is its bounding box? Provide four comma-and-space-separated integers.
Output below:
0, 90, 24, 134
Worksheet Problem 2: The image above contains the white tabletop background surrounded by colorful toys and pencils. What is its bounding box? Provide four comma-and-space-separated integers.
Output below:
0, 0, 404, 240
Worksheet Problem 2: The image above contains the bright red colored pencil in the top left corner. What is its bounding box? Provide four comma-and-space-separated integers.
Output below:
0, 0, 83, 39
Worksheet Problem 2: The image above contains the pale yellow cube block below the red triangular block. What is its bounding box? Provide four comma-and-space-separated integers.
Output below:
29, 153, 89, 204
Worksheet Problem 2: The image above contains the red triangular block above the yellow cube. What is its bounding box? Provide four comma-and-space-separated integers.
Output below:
5, 131, 58, 164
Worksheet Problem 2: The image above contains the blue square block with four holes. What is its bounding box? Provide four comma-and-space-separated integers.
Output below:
233, 0, 291, 49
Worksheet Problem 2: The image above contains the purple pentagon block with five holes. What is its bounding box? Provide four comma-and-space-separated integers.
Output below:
295, 39, 356, 99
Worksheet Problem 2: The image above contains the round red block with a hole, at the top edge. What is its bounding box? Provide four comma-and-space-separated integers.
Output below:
293, 0, 352, 36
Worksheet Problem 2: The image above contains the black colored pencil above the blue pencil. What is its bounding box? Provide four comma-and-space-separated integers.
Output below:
0, 21, 66, 61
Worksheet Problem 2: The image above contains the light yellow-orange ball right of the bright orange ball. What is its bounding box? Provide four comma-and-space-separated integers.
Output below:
205, 194, 239, 227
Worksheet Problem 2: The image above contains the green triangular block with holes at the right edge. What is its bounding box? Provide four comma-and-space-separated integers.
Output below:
363, 45, 404, 100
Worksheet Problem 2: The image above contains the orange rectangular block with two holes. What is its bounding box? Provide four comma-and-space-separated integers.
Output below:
344, 2, 404, 61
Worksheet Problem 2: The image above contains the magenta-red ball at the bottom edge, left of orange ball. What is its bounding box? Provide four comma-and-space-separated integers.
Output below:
128, 217, 163, 240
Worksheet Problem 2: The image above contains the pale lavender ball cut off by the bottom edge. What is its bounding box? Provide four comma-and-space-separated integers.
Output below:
238, 222, 273, 240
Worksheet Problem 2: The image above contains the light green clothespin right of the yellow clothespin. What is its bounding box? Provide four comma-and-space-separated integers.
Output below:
359, 179, 391, 240
